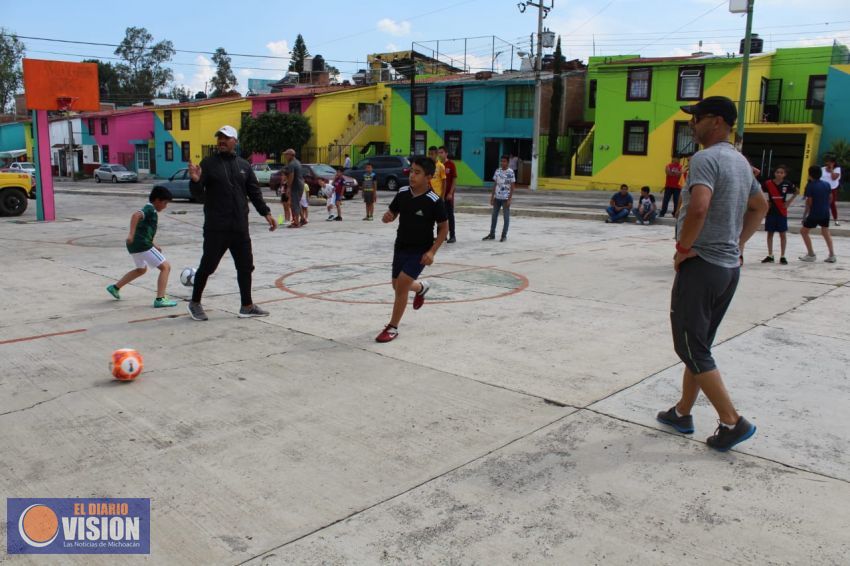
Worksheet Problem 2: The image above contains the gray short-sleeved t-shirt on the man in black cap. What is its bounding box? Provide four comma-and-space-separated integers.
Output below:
678, 142, 762, 267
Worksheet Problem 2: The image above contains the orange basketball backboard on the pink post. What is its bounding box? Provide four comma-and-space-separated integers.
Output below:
23, 59, 100, 112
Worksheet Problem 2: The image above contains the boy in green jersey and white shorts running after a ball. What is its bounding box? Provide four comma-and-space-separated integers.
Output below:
106, 187, 177, 309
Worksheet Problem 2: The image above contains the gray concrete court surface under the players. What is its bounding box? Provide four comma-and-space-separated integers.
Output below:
0, 193, 850, 565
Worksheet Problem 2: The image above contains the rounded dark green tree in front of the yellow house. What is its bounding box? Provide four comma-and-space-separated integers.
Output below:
239, 112, 313, 159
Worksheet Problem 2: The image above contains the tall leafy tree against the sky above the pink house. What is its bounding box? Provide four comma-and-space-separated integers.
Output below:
115, 27, 175, 100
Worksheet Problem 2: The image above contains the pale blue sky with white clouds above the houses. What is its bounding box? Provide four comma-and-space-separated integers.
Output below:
6, 0, 850, 93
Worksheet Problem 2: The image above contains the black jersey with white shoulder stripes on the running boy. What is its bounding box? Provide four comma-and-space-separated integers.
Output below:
390, 187, 448, 252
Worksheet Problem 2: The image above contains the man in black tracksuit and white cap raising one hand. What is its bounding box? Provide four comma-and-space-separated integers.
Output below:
189, 126, 277, 320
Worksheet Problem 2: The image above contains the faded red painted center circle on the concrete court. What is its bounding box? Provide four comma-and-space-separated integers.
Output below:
275, 262, 528, 305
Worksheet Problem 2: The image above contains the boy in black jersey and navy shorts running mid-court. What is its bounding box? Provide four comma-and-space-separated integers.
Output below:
375, 157, 449, 342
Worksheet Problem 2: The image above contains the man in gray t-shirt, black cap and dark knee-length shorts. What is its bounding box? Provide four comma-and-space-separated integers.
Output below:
657, 96, 767, 451
